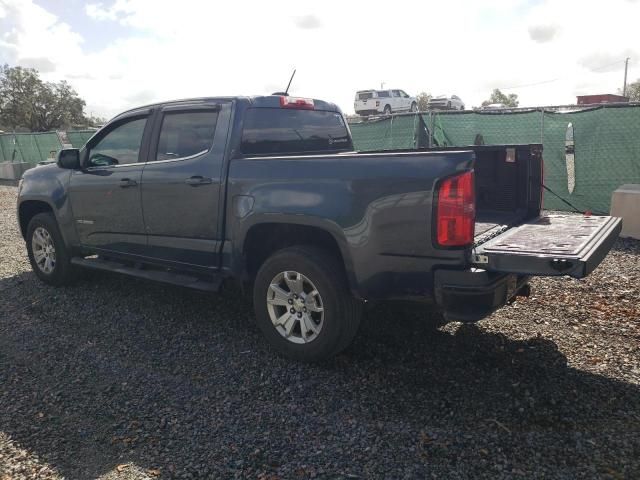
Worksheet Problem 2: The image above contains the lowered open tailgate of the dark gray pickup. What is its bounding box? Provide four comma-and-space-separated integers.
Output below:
472, 215, 622, 278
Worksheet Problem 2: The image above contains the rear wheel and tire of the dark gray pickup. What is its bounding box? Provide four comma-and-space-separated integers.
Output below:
253, 246, 362, 362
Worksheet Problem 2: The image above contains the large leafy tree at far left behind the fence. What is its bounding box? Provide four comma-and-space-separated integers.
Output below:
0, 65, 86, 132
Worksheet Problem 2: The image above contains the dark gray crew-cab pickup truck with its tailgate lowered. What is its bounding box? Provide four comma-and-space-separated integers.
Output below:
18, 95, 621, 360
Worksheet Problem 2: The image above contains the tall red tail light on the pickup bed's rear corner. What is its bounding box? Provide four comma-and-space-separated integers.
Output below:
436, 170, 476, 247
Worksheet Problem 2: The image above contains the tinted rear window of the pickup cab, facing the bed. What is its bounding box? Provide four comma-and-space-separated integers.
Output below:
241, 108, 353, 155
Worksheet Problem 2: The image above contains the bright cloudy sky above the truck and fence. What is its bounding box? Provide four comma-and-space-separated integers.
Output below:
0, 0, 640, 118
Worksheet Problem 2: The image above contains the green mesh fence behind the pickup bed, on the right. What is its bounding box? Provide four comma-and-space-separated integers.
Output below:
351, 105, 640, 213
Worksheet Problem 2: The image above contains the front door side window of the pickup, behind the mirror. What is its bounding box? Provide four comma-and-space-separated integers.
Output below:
87, 118, 147, 167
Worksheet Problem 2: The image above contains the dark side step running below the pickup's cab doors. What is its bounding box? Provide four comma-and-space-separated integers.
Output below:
71, 257, 222, 292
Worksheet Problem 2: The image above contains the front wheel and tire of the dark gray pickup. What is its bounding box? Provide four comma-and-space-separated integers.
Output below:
26, 213, 75, 287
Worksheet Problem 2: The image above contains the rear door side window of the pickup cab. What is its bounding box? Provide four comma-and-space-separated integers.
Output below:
154, 110, 218, 160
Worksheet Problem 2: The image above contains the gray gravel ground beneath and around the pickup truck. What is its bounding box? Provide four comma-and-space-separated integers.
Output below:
0, 186, 640, 480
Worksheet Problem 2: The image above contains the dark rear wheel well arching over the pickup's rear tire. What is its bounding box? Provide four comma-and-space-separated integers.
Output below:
242, 223, 344, 278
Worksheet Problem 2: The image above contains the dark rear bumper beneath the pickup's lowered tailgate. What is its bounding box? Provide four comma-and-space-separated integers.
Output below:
434, 269, 529, 322
